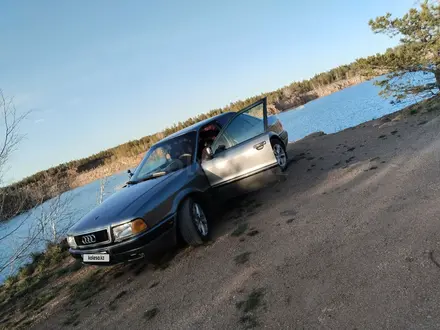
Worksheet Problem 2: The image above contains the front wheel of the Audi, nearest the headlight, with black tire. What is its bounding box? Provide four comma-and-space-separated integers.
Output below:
177, 197, 210, 246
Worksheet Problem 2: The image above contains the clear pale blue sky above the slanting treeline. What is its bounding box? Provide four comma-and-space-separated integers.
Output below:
0, 0, 414, 183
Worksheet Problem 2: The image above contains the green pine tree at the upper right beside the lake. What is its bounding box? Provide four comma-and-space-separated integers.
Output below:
364, 1, 440, 99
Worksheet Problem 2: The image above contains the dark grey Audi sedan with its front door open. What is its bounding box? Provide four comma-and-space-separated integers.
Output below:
67, 98, 288, 265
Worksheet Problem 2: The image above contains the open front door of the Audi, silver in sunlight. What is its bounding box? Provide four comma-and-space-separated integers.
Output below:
202, 98, 277, 196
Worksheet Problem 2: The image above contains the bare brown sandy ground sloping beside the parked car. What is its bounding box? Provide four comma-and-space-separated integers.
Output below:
36, 102, 440, 329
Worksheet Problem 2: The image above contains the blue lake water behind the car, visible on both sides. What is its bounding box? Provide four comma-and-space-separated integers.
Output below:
0, 76, 428, 283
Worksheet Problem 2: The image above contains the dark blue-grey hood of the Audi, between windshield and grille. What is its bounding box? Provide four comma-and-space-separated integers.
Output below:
68, 172, 177, 235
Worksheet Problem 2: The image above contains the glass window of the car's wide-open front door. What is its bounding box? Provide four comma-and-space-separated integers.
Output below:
212, 103, 264, 153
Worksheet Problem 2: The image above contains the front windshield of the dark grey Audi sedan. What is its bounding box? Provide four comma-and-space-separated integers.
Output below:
130, 132, 196, 182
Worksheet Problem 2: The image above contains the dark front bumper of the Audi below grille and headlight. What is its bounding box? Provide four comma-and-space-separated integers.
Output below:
69, 216, 176, 266
